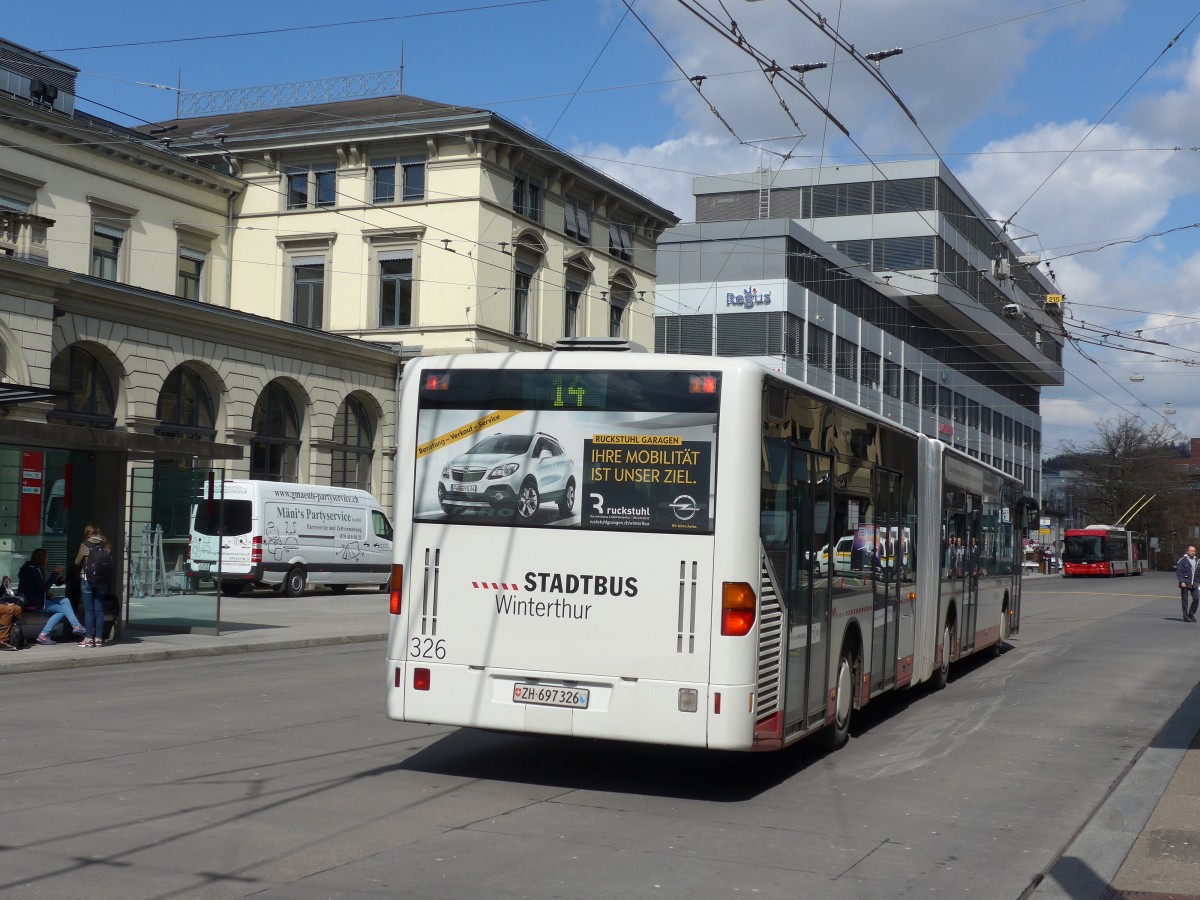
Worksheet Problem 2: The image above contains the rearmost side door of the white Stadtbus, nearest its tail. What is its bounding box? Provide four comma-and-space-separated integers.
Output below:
772, 445, 832, 734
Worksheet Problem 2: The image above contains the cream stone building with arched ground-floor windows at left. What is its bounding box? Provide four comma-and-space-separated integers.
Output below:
0, 35, 676, 588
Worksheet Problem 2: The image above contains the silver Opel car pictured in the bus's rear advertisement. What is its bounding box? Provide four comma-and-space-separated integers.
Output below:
438, 432, 575, 521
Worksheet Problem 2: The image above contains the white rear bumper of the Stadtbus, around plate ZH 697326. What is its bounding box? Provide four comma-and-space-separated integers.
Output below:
386, 660, 754, 750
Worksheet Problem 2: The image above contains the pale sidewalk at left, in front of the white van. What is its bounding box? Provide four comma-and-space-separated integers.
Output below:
0, 590, 388, 677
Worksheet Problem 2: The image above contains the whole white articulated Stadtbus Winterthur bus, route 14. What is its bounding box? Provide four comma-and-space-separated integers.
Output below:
386, 352, 1036, 750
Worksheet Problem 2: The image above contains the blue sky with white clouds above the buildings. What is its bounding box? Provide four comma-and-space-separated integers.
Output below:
9, 0, 1200, 454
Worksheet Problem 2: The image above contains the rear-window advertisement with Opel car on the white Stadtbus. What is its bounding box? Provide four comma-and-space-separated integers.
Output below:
413, 371, 716, 534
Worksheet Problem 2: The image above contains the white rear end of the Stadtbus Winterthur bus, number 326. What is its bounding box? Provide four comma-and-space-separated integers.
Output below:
386, 353, 758, 749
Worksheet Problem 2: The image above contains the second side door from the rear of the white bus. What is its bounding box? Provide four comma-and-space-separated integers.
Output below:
869, 467, 902, 692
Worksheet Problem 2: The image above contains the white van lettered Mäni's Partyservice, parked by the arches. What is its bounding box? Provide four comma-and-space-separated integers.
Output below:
187, 480, 391, 596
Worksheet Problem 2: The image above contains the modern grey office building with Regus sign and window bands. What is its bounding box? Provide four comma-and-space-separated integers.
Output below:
655, 161, 1064, 494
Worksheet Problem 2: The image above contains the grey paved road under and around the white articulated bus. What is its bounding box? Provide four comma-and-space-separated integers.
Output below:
0, 576, 1200, 900
